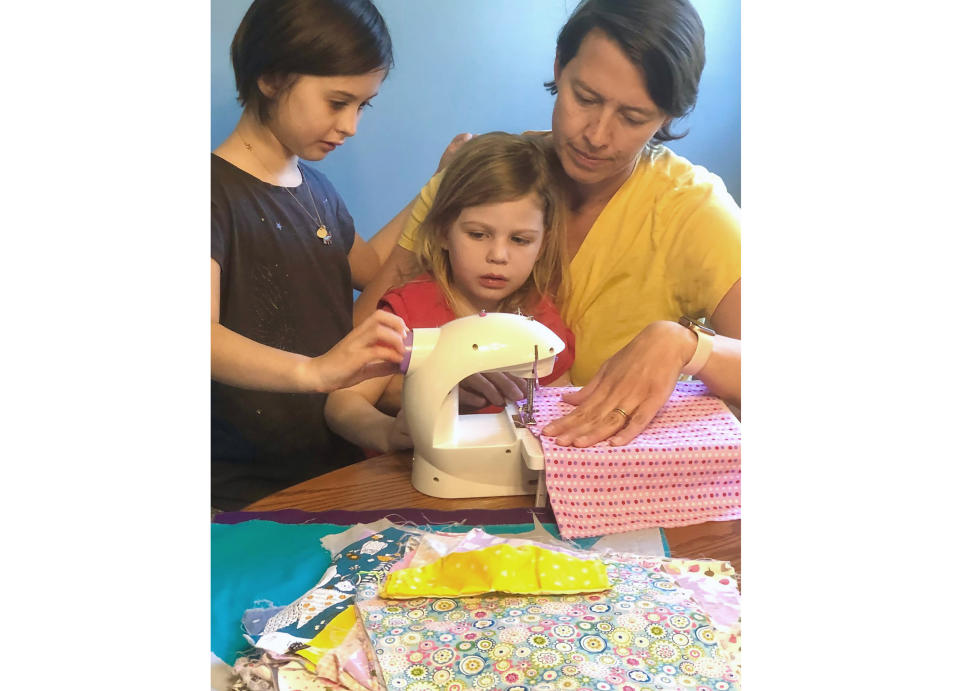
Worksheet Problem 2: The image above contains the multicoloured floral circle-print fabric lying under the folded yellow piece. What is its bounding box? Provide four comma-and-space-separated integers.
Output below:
357, 555, 738, 691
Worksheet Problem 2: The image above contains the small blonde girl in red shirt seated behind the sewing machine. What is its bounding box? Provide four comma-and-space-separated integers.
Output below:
325, 132, 574, 453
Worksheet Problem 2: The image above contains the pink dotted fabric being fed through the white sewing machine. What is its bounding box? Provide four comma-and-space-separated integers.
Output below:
532, 381, 740, 538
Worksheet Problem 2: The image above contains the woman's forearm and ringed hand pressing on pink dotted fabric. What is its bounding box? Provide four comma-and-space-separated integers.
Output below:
543, 279, 740, 447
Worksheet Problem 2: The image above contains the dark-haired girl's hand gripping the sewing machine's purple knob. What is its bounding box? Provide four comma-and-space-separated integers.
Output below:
304, 310, 408, 393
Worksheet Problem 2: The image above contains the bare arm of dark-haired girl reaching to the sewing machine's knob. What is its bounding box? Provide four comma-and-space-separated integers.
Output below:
210, 259, 406, 393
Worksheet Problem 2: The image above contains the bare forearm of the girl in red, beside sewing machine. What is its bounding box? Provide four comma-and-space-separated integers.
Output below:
323, 377, 413, 453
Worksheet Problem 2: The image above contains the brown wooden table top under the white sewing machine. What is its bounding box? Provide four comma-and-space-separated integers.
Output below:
244, 451, 740, 575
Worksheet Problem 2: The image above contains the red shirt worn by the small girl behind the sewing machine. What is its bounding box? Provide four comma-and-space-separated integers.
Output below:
377, 274, 574, 394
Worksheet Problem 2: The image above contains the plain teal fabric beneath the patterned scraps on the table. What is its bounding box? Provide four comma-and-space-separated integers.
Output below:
210, 520, 597, 664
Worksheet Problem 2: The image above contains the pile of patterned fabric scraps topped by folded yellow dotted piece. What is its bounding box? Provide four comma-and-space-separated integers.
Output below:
227, 520, 740, 691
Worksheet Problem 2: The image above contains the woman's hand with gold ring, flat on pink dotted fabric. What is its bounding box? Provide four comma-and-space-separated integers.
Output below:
543, 321, 697, 447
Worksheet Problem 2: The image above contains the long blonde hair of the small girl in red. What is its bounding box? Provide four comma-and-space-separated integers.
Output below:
414, 132, 567, 316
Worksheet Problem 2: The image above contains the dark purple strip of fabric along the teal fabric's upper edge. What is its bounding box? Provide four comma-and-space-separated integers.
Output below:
213, 507, 557, 525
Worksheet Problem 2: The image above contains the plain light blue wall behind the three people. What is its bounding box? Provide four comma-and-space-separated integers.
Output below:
210, 0, 740, 238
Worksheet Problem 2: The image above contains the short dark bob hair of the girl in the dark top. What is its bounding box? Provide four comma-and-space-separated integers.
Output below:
230, 0, 393, 122
